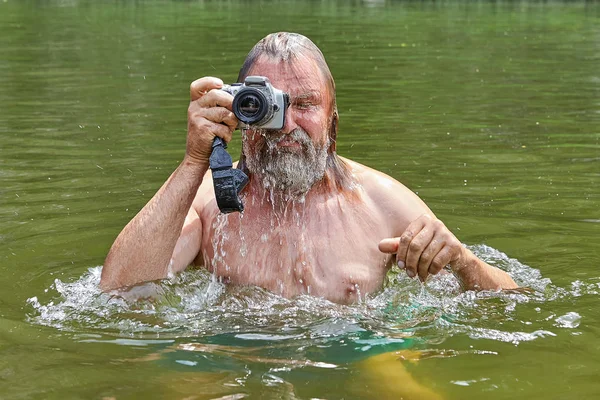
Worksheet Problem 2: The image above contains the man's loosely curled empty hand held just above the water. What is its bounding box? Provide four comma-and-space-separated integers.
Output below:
379, 214, 465, 282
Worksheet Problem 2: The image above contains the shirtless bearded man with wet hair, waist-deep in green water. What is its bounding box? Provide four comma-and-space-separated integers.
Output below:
100, 33, 517, 303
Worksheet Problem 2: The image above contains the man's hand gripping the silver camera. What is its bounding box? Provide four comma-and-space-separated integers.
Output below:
186, 76, 238, 166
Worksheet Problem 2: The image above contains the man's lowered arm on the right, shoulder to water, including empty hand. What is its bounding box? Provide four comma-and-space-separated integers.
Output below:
369, 166, 518, 290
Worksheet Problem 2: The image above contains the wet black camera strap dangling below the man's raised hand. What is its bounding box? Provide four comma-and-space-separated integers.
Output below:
209, 137, 248, 214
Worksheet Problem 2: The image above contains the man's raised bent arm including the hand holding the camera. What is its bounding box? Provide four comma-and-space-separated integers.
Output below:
100, 77, 238, 290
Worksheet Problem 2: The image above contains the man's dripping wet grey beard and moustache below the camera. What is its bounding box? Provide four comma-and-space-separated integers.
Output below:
244, 128, 328, 197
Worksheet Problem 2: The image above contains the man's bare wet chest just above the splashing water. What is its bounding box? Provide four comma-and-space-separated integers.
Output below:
202, 202, 389, 303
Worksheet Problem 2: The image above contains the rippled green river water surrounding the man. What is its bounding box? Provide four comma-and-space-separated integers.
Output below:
0, 0, 600, 399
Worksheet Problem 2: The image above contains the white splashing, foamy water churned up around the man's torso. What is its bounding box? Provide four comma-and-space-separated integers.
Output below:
28, 245, 600, 347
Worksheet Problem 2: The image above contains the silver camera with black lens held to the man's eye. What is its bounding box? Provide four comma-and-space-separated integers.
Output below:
221, 76, 289, 129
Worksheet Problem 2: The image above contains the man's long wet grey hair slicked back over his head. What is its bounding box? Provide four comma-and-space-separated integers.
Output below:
237, 32, 351, 189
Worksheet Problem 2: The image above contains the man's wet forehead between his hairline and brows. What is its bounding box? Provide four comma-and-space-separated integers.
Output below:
249, 57, 327, 97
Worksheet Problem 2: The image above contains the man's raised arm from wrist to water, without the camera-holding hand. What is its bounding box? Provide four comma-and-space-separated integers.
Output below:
100, 160, 208, 290
